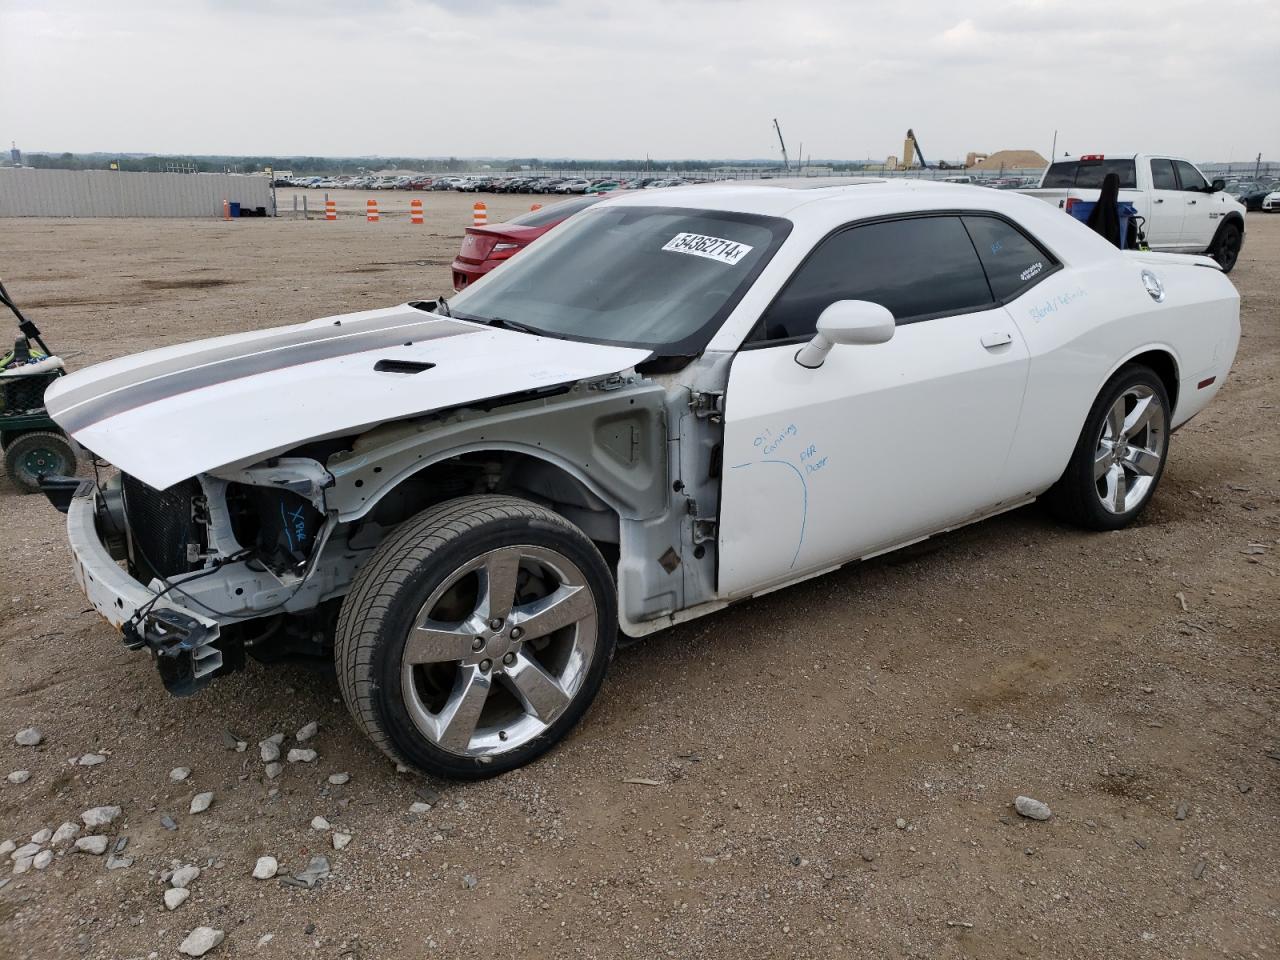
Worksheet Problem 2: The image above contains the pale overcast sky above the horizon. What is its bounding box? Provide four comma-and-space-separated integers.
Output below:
0, 0, 1280, 161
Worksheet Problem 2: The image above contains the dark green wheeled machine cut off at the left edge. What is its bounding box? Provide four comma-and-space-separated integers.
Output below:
0, 276, 76, 493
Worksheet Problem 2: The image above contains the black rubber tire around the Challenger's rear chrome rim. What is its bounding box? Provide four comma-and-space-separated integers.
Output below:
1042, 364, 1172, 530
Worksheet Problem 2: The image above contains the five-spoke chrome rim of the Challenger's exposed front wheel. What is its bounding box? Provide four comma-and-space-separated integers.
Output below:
401, 545, 598, 756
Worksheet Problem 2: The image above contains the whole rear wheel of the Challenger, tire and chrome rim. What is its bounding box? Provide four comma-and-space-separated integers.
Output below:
1044, 365, 1170, 530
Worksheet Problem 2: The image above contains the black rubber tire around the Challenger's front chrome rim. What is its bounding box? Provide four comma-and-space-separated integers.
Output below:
334, 495, 618, 780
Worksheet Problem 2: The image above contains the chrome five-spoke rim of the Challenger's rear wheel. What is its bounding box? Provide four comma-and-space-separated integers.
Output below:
1093, 384, 1166, 513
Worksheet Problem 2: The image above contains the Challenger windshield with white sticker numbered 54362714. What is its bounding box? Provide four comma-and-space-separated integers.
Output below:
448, 205, 791, 356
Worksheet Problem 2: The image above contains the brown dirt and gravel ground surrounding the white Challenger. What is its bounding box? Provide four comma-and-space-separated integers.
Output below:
0, 197, 1280, 960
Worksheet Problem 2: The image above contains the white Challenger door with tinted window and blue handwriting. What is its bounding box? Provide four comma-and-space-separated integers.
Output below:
718, 215, 1039, 596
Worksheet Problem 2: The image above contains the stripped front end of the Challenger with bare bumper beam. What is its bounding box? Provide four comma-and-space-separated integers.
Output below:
60, 457, 349, 696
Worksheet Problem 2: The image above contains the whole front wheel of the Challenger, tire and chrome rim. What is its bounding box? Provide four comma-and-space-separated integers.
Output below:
334, 495, 618, 780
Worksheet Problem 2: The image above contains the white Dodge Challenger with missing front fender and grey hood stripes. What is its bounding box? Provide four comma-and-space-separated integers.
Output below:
45, 179, 1239, 778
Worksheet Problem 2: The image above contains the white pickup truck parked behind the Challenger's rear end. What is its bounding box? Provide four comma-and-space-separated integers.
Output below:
1021, 154, 1244, 271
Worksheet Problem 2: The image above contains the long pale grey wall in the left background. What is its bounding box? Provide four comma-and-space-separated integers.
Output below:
0, 169, 275, 216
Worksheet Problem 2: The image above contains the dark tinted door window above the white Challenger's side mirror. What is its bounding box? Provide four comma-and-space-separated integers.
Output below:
750, 216, 992, 342
